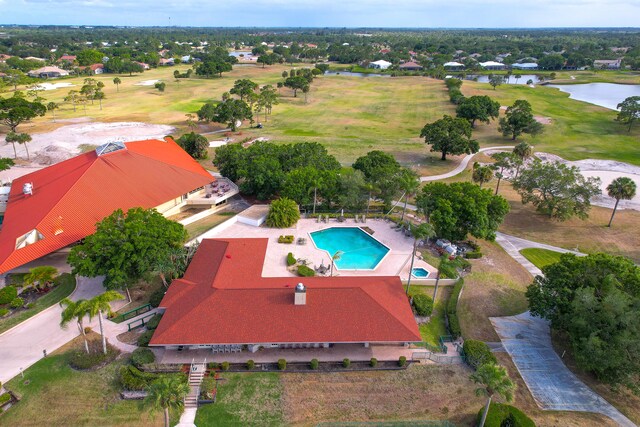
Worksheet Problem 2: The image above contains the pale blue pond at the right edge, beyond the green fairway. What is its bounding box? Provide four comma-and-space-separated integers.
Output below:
548, 83, 640, 110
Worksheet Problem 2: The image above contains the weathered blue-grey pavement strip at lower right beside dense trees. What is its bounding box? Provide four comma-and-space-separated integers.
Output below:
490, 312, 635, 427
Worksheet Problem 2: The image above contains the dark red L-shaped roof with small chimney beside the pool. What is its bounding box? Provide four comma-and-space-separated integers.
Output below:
151, 239, 422, 346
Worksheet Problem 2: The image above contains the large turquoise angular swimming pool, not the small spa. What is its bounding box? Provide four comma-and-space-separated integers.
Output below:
311, 227, 390, 270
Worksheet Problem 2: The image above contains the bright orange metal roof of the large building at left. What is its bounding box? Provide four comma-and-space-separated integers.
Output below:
0, 138, 214, 273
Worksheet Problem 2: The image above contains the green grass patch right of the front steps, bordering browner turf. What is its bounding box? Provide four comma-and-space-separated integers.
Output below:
195, 372, 285, 426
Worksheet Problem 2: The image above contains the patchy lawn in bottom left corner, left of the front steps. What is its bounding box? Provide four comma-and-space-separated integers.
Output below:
0, 341, 166, 426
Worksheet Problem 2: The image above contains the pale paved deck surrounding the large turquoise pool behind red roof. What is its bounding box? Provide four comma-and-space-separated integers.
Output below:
201, 219, 436, 280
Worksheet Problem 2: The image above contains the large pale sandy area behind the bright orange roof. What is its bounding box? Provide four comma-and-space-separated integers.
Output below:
0, 122, 174, 166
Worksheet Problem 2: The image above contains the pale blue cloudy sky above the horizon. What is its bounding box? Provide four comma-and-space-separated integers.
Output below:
0, 0, 640, 28
